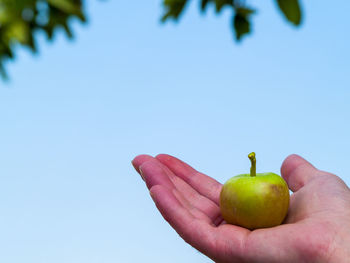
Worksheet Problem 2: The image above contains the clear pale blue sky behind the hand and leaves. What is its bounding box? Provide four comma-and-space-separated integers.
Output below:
0, 0, 350, 263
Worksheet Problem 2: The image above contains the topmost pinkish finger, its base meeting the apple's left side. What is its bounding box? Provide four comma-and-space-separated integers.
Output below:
156, 154, 222, 205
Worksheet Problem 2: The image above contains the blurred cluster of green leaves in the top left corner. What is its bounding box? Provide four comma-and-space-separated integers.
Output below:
0, 0, 86, 80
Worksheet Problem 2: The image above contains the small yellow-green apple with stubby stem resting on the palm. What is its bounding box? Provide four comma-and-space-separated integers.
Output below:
220, 153, 289, 230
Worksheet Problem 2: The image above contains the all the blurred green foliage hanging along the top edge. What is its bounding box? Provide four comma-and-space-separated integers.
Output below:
0, 0, 302, 79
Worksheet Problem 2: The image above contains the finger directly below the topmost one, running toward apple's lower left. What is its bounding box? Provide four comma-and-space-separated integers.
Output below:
139, 158, 221, 224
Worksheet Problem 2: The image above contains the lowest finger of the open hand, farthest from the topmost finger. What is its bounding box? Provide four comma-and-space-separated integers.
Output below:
150, 185, 220, 258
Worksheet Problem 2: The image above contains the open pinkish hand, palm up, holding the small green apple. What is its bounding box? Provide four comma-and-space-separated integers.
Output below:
132, 154, 350, 263
